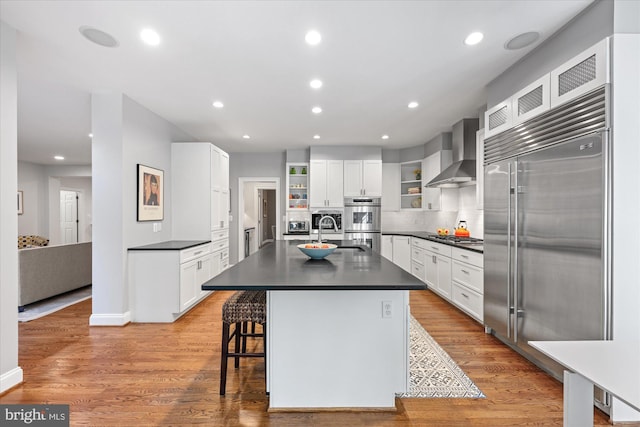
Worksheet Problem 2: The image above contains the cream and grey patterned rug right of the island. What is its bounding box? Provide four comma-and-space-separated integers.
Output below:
397, 316, 485, 398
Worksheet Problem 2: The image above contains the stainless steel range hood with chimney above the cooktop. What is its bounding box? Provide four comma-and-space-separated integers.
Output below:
425, 119, 480, 187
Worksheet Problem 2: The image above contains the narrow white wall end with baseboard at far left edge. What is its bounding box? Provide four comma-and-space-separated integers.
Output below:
0, 21, 22, 393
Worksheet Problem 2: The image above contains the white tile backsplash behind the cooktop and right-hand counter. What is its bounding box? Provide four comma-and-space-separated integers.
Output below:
382, 185, 484, 239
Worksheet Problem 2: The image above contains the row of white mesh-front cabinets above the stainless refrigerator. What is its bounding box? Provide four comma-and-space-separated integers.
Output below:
484, 38, 610, 138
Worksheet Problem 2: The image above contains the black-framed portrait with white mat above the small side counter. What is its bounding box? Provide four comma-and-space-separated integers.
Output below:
138, 164, 164, 221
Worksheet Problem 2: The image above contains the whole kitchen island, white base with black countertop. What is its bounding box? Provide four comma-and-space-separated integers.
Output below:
202, 241, 426, 411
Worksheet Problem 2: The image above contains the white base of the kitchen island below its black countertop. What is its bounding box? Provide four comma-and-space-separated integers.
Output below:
267, 290, 410, 411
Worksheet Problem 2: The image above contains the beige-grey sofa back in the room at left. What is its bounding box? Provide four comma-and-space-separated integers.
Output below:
18, 242, 91, 308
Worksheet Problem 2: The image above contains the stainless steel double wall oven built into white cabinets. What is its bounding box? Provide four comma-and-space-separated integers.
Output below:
344, 197, 382, 253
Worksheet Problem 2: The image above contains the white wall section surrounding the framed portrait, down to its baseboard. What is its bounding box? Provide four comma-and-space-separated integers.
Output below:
90, 93, 196, 325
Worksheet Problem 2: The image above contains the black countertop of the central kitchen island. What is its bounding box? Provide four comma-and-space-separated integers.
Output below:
202, 240, 427, 291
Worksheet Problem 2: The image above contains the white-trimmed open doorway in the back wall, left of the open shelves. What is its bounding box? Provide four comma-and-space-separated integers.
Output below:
238, 177, 280, 261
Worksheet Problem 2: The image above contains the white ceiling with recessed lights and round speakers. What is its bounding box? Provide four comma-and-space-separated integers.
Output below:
0, 0, 592, 165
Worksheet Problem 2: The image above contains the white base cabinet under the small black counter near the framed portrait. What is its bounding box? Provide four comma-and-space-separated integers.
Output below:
129, 243, 213, 322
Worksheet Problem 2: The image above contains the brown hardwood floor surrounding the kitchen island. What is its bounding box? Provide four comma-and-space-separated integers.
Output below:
0, 291, 609, 427
